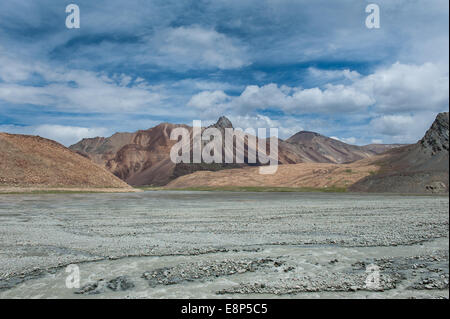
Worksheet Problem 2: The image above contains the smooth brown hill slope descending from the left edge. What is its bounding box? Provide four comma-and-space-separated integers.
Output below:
0, 133, 131, 189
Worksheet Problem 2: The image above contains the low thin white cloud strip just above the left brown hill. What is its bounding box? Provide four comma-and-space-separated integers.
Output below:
0, 124, 109, 146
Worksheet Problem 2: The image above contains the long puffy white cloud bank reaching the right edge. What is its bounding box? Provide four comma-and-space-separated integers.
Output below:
188, 63, 449, 114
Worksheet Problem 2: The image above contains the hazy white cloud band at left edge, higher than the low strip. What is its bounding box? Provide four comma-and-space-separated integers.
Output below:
0, 51, 163, 113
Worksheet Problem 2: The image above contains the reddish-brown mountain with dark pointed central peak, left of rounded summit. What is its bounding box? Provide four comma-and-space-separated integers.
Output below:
70, 116, 282, 186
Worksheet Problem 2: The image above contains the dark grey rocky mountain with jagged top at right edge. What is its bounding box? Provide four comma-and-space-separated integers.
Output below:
351, 112, 449, 193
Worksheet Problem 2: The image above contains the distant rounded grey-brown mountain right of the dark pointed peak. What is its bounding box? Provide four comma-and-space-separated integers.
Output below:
284, 131, 397, 164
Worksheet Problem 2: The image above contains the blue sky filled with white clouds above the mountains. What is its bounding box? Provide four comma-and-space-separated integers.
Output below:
0, 0, 449, 146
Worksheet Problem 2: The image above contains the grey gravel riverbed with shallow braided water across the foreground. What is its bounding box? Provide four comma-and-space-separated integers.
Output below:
0, 191, 449, 298
